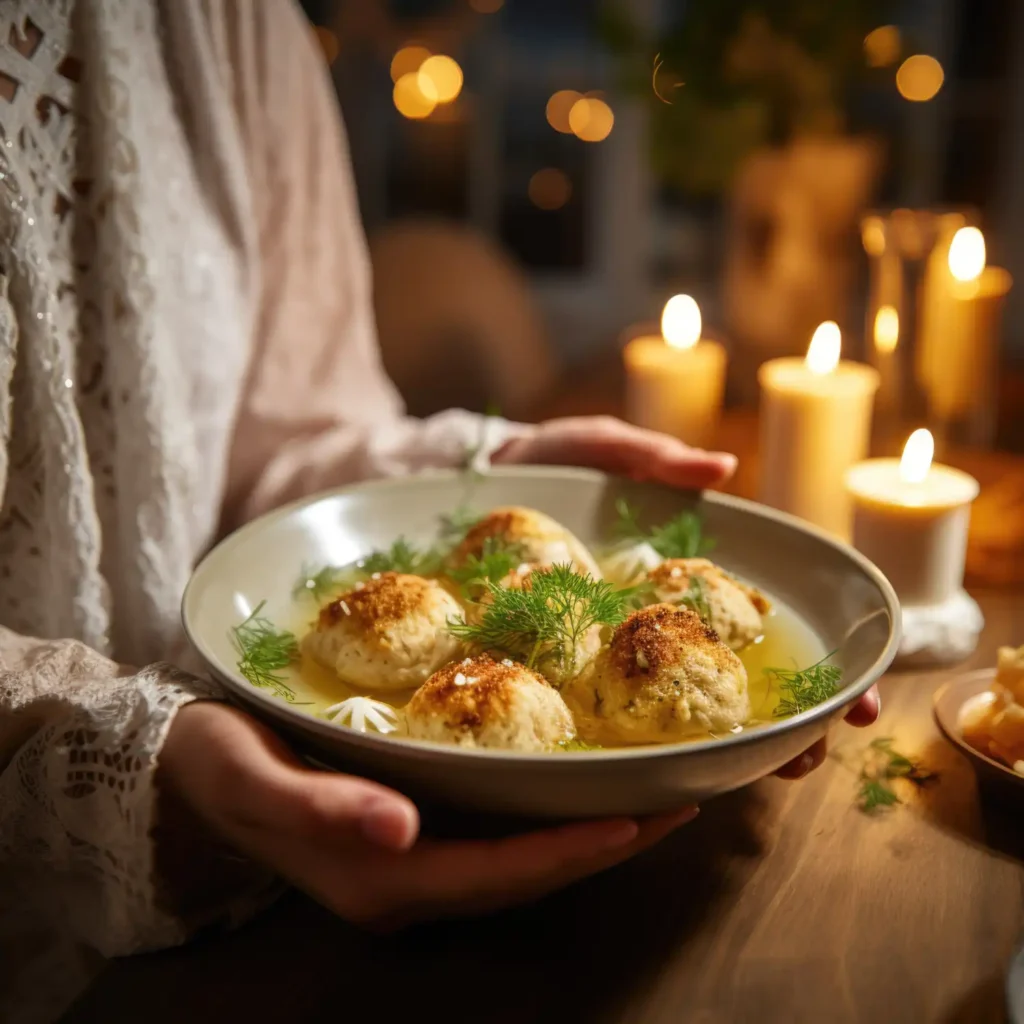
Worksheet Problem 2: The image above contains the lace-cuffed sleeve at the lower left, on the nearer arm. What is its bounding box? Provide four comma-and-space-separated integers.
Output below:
0, 630, 274, 974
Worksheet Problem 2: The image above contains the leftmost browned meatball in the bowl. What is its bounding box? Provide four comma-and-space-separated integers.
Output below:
303, 572, 462, 690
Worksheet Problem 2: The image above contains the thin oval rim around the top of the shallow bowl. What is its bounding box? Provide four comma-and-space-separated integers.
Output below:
181, 465, 902, 766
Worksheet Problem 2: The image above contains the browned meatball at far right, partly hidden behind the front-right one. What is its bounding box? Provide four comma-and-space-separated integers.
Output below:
647, 558, 771, 650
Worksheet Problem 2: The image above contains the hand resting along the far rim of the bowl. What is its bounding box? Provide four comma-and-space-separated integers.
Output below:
490, 416, 736, 488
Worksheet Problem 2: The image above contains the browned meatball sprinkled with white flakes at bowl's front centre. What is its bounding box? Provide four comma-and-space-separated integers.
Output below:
406, 656, 575, 752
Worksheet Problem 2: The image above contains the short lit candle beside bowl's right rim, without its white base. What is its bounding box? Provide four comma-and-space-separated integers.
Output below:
846, 430, 978, 607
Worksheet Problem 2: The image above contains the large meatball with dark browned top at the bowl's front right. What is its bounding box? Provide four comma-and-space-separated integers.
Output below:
563, 604, 751, 743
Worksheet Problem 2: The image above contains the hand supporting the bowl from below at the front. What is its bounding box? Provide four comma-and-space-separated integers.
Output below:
160, 701, 696, 928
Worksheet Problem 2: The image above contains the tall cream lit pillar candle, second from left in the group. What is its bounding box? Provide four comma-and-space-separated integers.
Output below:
758, 321, 879, 539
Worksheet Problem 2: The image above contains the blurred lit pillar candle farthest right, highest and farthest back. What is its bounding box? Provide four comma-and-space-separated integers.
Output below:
918, 227, 1013, 422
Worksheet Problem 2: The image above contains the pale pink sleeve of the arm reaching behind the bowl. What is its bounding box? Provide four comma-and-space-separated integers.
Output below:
216, 2, 531, 526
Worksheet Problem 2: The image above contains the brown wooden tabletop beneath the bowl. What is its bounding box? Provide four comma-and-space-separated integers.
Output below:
66, 376, 1024, 1024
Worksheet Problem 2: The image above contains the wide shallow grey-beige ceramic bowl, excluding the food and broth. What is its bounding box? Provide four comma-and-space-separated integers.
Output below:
183, 467, 899, 817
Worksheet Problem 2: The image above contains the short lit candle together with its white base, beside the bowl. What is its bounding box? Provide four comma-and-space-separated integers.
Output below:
847, 430, 984, 664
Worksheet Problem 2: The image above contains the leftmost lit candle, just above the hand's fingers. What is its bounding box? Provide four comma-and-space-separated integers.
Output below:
623, 295, 726, 447
